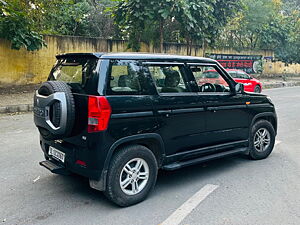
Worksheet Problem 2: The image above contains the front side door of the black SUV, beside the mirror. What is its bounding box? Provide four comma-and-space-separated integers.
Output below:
188, 63, 249, 146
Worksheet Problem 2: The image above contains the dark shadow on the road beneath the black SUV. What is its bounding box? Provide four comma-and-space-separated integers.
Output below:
39, 156, 251, 209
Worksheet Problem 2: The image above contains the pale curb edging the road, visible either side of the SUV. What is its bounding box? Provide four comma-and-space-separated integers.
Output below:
0, 81, 300, 114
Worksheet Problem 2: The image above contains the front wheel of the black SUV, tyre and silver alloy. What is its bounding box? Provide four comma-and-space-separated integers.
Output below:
249, 120, 276, 160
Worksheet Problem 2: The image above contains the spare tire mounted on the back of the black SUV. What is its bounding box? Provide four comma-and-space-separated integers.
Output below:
38, 81, 75, 140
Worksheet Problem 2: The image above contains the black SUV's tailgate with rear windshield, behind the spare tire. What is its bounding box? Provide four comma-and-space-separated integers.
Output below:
48, 54, 99, 142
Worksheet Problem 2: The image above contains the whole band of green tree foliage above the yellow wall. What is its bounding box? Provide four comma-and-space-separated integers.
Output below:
0, 0, 300, 63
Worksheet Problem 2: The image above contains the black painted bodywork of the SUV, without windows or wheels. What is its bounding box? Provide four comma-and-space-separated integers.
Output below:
41, 53, 277, 188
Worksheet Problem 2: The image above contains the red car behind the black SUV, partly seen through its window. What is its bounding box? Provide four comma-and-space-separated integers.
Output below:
198, 69, 262, 93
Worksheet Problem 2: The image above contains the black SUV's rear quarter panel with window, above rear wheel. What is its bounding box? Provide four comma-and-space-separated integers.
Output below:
103, 59, 157, 141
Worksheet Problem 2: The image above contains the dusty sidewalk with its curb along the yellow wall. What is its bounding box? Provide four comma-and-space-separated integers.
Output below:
0, 77, 300, 114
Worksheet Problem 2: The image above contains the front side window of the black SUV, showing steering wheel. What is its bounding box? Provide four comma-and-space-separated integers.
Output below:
190, 65, 230, 92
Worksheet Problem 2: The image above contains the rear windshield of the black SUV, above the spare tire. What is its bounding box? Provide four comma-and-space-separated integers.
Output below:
49, 57, 98, 87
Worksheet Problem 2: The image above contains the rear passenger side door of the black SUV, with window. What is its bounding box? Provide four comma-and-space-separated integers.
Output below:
145, 62, 205, 159
